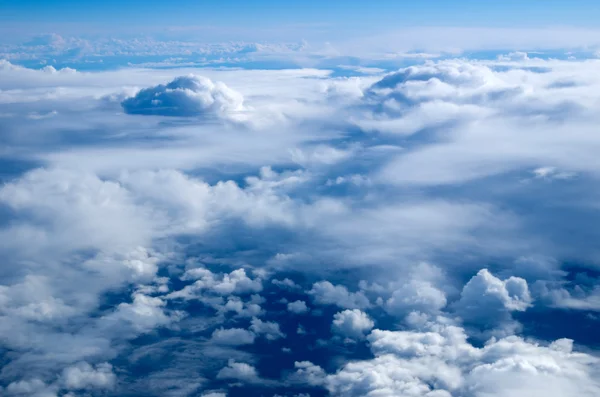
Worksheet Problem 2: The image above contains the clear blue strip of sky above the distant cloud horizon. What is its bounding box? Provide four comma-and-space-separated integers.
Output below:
0, 0, 600, 38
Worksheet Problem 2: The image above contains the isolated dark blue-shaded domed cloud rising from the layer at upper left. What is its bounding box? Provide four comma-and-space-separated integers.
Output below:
121, 75, 244, 120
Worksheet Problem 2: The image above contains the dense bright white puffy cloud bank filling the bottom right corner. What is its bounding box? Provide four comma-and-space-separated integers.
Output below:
324, 323, 600, 397
